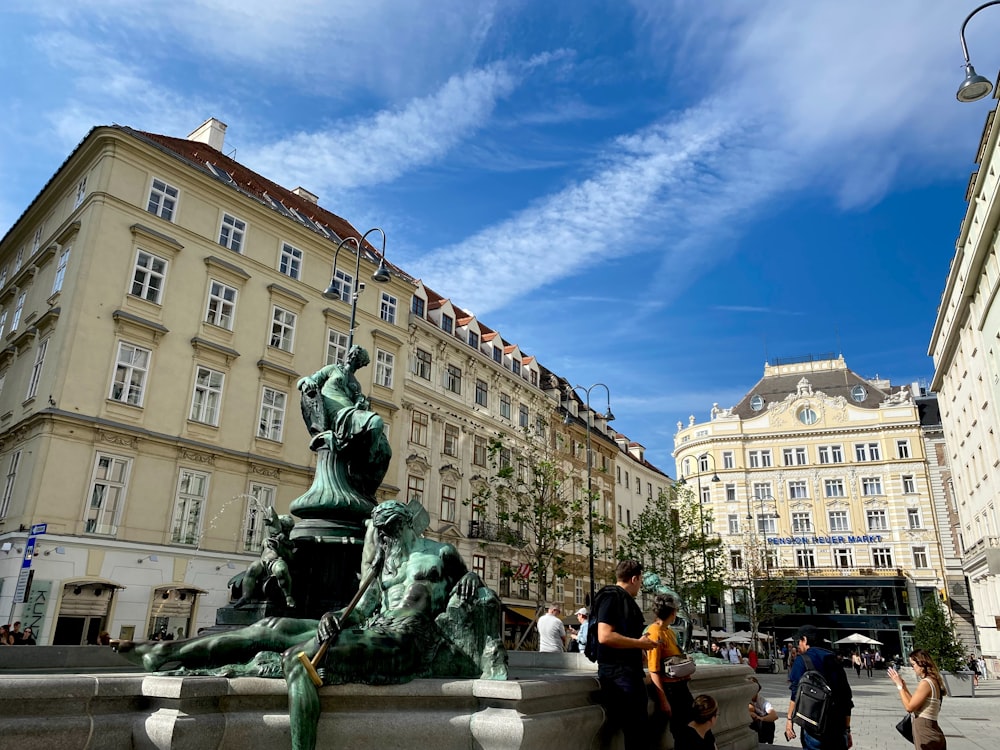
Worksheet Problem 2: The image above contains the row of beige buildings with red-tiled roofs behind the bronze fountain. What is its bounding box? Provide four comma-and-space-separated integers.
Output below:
0, 119, 648, 643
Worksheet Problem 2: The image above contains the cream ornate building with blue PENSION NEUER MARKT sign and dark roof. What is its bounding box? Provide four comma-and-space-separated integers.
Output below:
674, 357, 945, 653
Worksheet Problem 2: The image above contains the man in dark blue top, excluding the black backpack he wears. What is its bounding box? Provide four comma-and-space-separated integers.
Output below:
785, 625, 854, 750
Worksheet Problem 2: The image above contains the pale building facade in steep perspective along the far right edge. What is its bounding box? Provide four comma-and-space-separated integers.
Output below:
928, 104, 1000, 657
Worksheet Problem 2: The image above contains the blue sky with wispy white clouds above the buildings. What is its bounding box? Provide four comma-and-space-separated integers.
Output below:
0, 0, 1000, 474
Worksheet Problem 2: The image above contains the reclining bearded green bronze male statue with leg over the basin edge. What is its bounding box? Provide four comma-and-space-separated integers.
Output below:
120, 500, 507, 750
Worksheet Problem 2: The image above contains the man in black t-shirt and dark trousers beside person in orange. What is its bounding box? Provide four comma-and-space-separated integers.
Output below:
591, 560, 656, 750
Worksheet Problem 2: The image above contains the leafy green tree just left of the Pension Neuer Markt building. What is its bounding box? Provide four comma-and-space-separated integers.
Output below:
618, 485, 726, 624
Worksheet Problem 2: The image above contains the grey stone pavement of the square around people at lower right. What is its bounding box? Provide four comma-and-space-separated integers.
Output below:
757, 670, 1000, 750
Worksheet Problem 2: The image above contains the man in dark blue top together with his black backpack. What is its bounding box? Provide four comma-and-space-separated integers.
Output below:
785, 625, 854, 750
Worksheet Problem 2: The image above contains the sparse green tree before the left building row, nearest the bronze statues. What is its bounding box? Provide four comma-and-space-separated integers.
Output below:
466, 430, 611, 606
